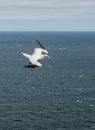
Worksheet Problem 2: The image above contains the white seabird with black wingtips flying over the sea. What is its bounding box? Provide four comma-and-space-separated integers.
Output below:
22, 40, 49, 68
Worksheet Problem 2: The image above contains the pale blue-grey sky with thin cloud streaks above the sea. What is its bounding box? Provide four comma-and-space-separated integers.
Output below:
0, 0, 95, 31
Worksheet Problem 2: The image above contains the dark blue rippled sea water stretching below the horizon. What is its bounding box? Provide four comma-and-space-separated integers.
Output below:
0, 32, 95, 130
